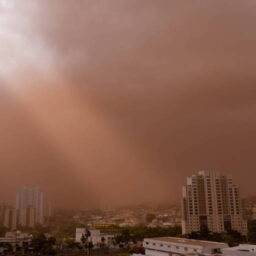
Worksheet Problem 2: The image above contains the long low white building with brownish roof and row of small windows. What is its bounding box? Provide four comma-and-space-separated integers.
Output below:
143, 237, 228, 256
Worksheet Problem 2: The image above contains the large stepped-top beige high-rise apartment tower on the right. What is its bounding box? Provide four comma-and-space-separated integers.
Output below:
182, 171, 247, 235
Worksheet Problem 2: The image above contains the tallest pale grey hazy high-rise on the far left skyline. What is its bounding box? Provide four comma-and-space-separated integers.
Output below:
16, 187, 44, 225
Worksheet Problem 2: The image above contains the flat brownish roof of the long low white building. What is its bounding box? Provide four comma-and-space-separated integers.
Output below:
145, 237, 228, 247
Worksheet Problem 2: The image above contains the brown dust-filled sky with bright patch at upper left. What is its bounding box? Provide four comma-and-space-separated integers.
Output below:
0, 0, 256, 208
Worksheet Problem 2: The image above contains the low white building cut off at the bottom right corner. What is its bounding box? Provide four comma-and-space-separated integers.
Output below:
223, 244, 256, 256
